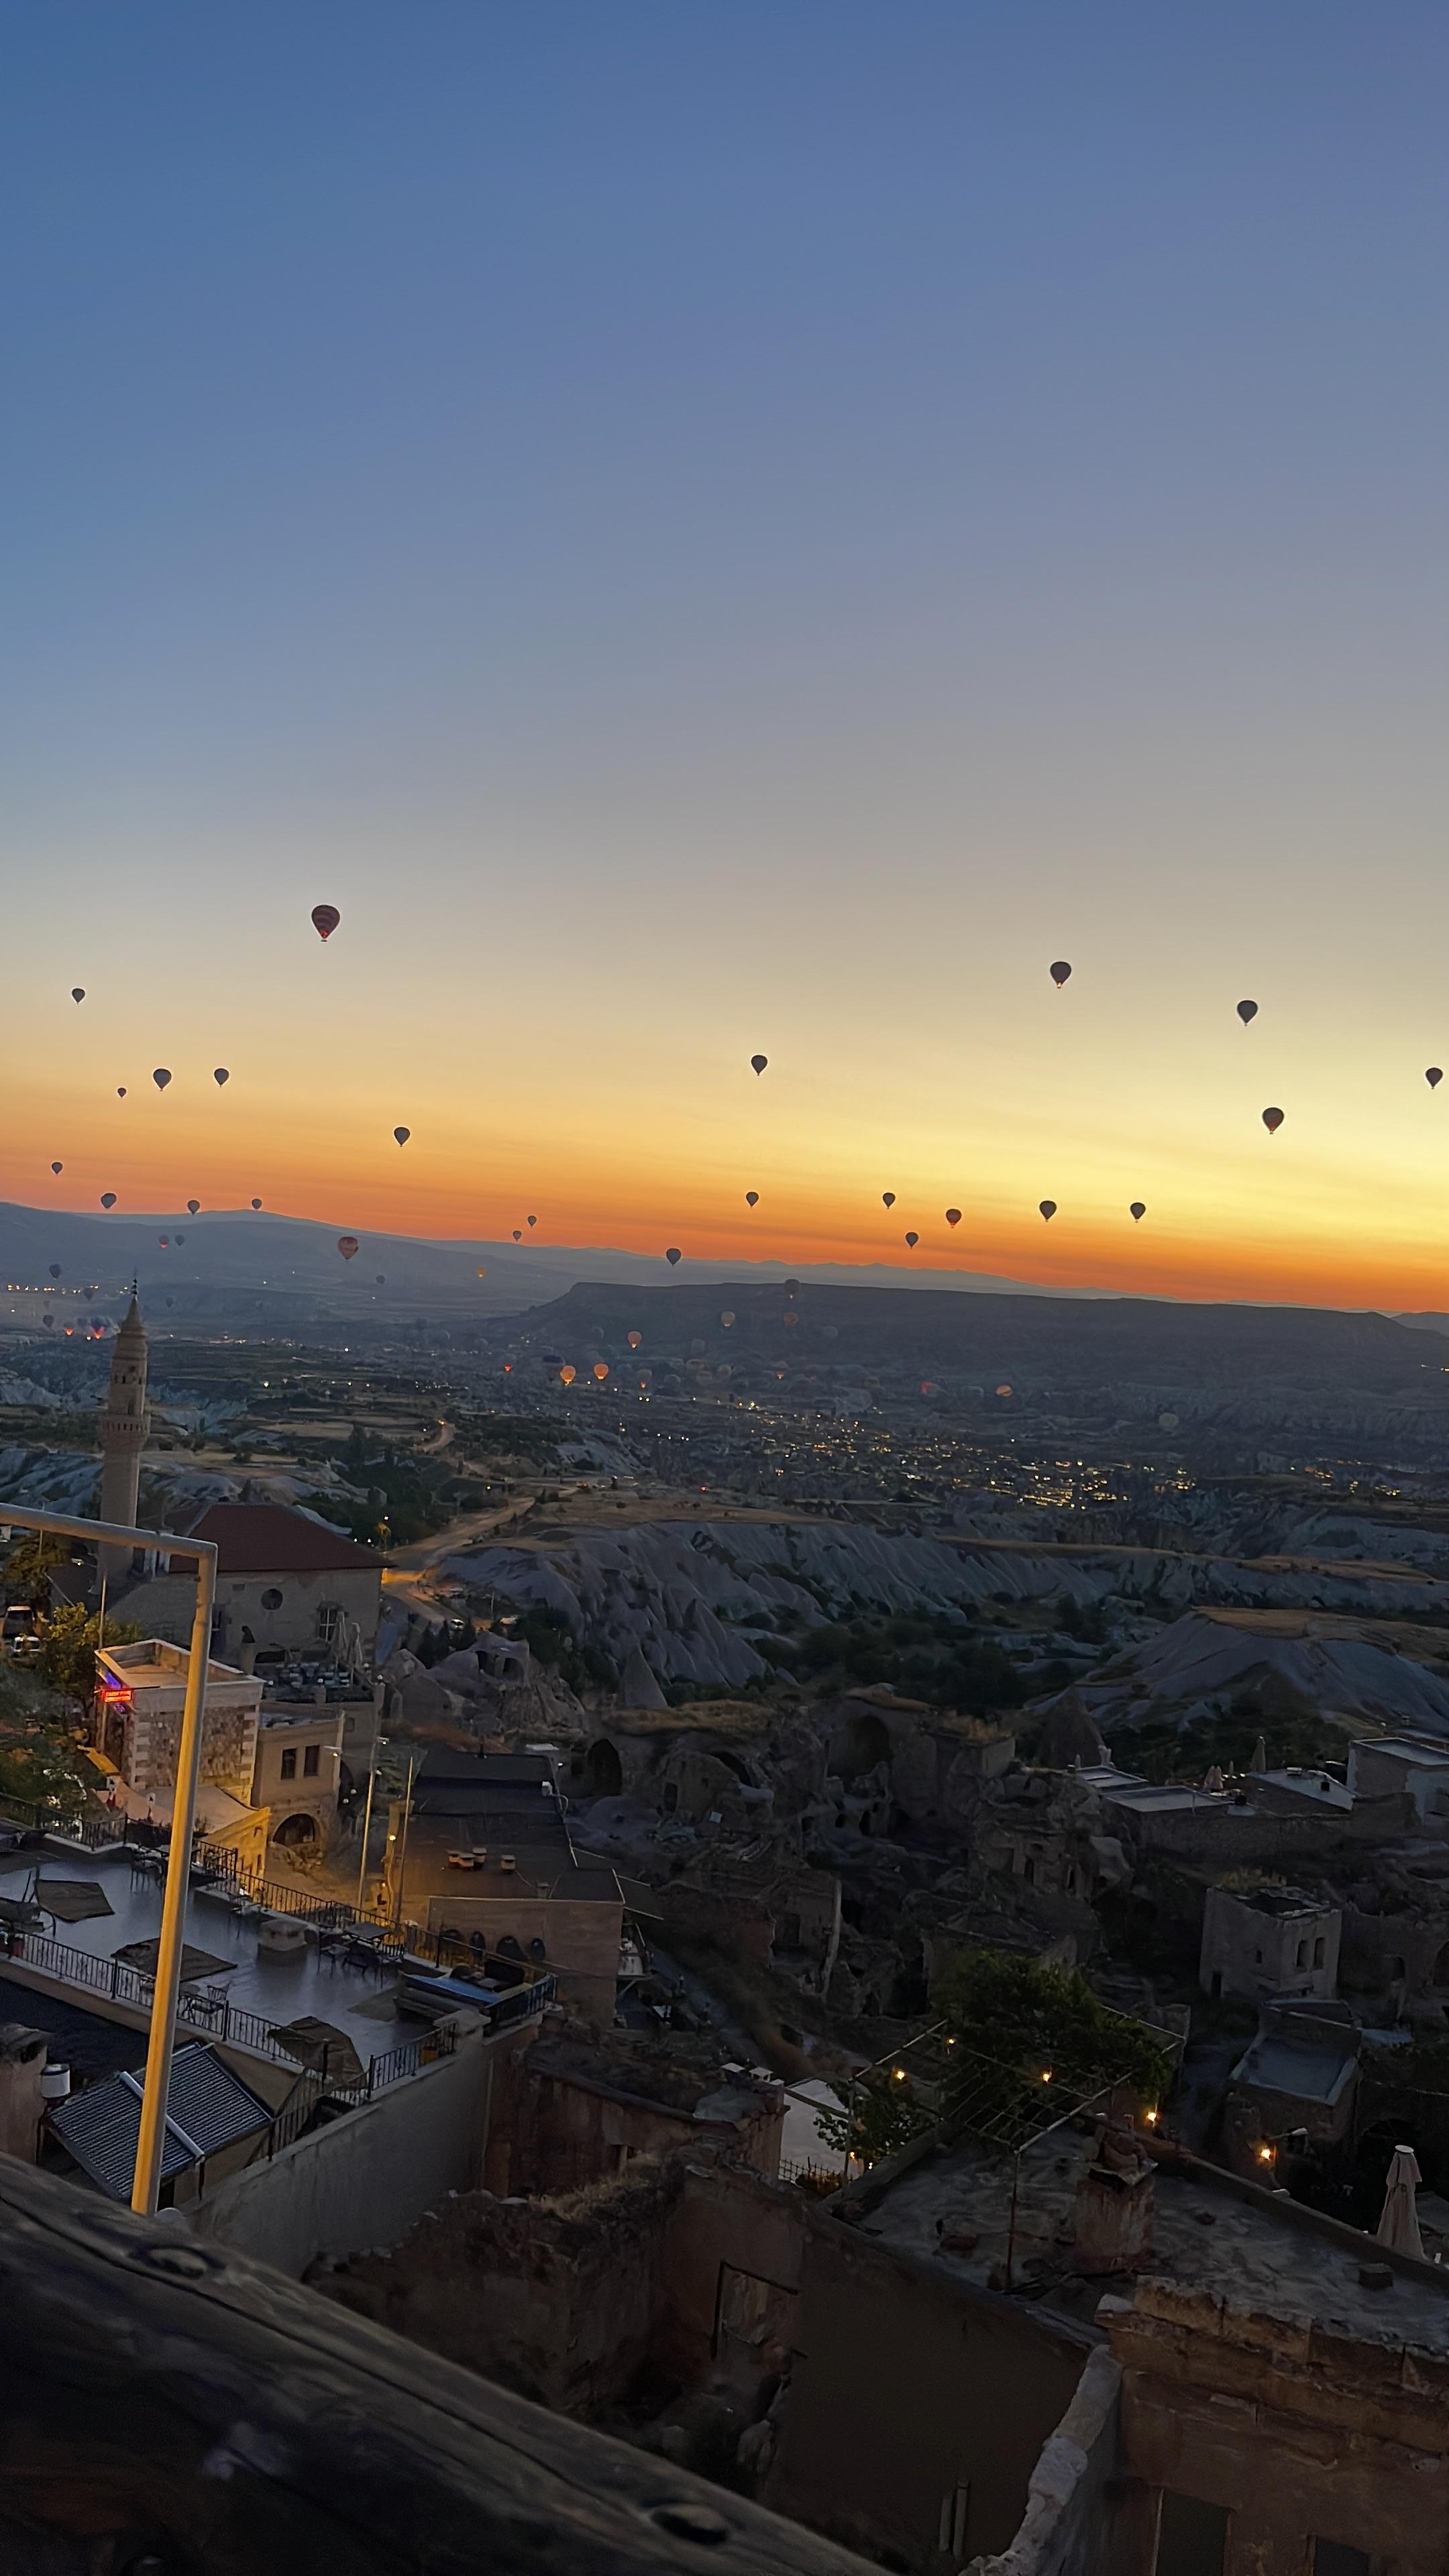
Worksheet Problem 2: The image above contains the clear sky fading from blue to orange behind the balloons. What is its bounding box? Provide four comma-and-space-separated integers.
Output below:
0, 0, 1449, 1303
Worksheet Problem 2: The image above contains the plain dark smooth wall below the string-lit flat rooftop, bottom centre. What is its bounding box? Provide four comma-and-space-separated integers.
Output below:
763, 2218, 1091, 2568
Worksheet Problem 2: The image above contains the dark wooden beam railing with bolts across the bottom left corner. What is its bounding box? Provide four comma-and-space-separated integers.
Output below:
0, 2156, 869, 2576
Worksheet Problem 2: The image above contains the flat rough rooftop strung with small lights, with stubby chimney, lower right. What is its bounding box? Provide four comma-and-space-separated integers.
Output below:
853, 2131, 1449, 2355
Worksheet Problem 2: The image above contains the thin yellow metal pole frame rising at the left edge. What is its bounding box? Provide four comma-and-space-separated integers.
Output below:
0, 1502, 217, 2218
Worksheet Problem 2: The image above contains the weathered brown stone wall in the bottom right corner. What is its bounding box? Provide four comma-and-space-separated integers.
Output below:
1098, 2277, 1449, 2576
